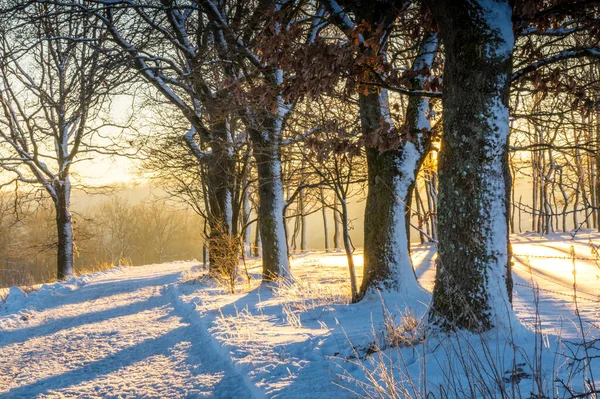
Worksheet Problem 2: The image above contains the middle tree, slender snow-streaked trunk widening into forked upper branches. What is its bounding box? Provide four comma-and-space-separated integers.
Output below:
199, 0, 326, 281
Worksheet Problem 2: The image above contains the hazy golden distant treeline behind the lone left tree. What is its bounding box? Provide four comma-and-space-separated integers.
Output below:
0, 192, 203, 287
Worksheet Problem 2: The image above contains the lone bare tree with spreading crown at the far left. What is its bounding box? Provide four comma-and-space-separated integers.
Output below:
0, 4, 125, 279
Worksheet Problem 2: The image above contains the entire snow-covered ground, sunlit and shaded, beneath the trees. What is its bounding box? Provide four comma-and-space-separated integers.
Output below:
0, 233, 600, 398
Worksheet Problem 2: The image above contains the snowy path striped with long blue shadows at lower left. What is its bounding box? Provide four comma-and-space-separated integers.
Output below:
0, 263, 252, 398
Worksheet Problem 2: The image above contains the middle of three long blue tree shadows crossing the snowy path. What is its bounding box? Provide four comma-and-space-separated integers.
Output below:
0, 296, 165, 348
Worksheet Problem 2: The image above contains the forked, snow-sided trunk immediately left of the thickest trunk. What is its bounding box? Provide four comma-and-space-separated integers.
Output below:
359, 33, 437, 297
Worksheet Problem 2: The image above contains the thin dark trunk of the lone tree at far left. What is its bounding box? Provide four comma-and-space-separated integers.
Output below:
54, 178, 75, 280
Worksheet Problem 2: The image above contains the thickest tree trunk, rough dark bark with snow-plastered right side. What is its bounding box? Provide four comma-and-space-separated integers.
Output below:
429, 0, 514, 331
